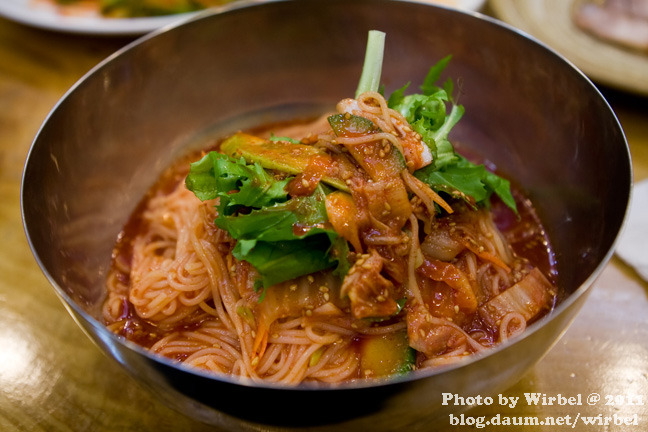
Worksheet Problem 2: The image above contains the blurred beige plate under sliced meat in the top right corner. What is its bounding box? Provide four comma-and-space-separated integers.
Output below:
489, 0, 648, 96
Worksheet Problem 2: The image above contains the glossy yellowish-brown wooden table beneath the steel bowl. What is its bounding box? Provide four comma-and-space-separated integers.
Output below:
0, 9, 648, 431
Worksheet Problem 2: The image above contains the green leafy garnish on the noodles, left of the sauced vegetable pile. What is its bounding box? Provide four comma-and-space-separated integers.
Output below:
185, 152, 349, 288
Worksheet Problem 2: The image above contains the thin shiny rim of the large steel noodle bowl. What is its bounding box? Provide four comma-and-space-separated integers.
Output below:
20, 0, 633, 391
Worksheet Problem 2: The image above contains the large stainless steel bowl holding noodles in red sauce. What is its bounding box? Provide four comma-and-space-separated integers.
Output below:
22, 0, 631, 430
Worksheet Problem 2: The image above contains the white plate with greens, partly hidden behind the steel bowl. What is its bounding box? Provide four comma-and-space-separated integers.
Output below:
0, 0, 485, 36
